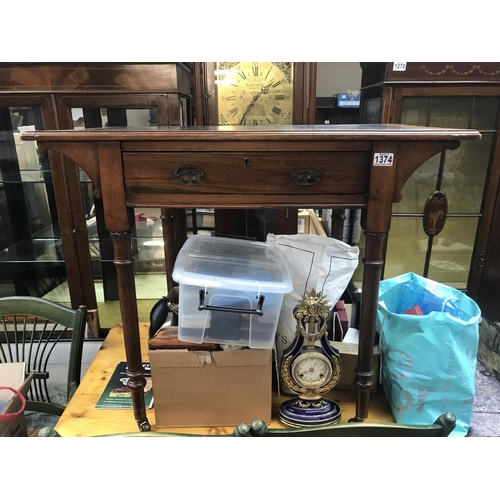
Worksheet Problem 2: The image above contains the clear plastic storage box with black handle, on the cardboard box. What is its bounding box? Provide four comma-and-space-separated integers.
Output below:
172, 235, 293, 349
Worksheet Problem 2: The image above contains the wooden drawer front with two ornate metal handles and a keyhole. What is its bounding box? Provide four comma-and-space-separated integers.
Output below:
123, 152, 370, 199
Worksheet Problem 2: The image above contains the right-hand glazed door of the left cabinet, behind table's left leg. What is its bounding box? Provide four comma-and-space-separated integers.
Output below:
49, 93, 192, 329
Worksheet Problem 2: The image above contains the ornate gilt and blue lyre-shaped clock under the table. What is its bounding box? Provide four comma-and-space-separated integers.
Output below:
279, 290, 341, 427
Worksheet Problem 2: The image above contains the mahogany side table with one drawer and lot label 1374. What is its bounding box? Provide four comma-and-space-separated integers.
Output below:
22, 125, 481, 431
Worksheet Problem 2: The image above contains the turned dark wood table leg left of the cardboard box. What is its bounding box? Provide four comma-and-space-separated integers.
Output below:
111, 231, 151, 431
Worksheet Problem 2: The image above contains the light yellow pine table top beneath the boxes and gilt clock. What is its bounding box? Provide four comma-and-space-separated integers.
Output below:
55, 323, 394, 437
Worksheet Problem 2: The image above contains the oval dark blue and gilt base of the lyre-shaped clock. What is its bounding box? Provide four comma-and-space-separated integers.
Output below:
279, 398, 342, 427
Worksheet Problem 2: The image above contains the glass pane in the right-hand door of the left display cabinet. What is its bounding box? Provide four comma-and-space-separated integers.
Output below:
53, 102, 172, 329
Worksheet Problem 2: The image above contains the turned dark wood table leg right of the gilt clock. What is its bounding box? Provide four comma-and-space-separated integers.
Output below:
350, 231, 387, 422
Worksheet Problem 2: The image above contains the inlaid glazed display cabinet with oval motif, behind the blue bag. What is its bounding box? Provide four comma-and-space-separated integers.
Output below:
360, 63, 500, 321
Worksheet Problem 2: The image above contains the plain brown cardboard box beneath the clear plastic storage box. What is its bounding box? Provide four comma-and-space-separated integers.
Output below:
149, 349, 273, 427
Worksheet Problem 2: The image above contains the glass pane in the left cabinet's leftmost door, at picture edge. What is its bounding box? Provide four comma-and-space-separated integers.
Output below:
0, 104, 66, 297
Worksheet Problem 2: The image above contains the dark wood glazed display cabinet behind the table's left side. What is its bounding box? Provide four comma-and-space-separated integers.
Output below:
0, 63, 194, 337
